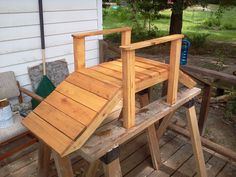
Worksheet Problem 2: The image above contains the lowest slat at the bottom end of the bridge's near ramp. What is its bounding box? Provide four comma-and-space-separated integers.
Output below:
22, 112, 72, 153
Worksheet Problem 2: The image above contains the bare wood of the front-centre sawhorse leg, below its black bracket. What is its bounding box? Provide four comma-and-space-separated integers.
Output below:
103, 158, 122, 177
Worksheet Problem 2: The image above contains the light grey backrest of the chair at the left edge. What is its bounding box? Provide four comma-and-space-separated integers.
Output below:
0, 71, 20, 99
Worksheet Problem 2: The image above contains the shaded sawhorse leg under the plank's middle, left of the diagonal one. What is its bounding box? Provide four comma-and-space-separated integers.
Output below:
147, 124, 161, 170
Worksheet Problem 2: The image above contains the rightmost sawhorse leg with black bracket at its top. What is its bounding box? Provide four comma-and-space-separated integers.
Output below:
185, 99, 207, 177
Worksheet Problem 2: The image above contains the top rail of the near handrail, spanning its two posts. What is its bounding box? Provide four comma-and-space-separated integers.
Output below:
120, 34, 184, 50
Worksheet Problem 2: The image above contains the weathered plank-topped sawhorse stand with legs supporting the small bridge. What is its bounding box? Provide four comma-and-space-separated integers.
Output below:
36, 88, 207, 177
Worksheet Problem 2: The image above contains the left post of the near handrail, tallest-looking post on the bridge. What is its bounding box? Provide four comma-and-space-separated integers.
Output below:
121, 51, 135, 128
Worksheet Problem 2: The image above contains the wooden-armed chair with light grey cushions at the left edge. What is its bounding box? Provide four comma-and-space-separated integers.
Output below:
0, 71, 43, 161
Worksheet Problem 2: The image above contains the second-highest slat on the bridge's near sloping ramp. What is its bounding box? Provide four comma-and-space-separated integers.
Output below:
56, 81, 107, 112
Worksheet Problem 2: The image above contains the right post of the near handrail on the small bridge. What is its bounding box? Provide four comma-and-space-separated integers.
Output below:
167, 39, 182, 104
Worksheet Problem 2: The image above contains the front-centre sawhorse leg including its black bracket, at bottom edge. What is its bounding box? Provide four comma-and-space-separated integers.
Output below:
100, 147, 122, 177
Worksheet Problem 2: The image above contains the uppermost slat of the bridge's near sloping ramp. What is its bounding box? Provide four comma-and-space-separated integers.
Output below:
66, 72, 119, 99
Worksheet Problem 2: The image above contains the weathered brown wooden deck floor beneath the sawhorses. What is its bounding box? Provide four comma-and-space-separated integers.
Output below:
0, 131, 236, 177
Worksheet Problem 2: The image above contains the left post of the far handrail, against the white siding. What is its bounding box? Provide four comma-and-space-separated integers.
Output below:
73, 37, 85, 71
